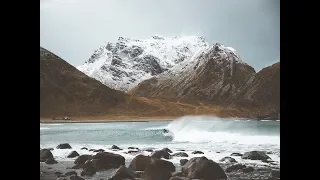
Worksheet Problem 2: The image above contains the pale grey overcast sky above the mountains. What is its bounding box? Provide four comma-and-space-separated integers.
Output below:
40, 0, 280, 71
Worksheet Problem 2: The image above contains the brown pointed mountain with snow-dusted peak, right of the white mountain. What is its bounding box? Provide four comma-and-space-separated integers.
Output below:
129, 44, 255, 105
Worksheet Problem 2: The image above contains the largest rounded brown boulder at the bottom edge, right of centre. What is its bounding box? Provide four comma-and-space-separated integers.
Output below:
181, 156, 227, 180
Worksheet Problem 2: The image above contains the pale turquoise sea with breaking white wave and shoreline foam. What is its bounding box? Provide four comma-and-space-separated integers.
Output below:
40, 116, 280, 167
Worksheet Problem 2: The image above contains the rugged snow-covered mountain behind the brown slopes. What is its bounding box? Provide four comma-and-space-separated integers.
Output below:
77, 36, 209, 92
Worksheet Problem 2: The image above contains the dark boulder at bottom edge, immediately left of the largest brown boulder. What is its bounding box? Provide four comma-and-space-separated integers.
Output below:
142, 159, 175, 180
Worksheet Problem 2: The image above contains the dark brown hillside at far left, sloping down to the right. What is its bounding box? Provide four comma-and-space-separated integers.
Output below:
40, 46, 127, 117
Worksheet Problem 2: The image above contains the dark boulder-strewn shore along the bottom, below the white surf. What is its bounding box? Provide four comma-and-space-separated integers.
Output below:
40, 144, 280, 180
